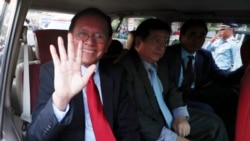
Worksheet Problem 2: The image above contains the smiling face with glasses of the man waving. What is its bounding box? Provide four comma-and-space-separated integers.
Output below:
72, 15, 111, 66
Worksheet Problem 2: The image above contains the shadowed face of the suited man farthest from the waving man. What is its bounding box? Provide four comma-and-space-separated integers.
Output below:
180, 26, 206, 53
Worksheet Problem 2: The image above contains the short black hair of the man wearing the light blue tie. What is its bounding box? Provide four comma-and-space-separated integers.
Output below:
135, 18, 172, 40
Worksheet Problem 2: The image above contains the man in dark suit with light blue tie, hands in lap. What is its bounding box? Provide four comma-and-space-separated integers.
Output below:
117, 19, 228, 141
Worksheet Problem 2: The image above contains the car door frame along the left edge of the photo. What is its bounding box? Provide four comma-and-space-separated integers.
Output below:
0, 0, 31, 141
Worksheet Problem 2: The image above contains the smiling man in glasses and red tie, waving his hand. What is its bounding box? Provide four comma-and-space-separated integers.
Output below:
27, 8, 140, 141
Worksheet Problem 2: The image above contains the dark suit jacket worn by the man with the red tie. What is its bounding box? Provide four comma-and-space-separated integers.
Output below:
27, 62, 140, 141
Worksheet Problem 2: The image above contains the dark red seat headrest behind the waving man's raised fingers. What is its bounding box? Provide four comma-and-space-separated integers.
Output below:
34, 29, 68, 64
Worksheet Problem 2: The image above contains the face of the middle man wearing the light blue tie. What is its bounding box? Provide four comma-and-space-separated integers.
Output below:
135, 30, 169, 63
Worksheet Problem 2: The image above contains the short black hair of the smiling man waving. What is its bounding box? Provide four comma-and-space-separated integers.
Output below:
69, 7, 113, 37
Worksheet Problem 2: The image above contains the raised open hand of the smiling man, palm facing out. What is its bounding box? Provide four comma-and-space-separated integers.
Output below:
50, 33, 95, 111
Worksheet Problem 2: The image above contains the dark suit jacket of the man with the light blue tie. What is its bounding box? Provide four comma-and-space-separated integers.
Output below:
118, 48, 184, 141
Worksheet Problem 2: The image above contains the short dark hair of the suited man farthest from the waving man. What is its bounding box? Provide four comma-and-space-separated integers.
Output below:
180, 19, 208, 35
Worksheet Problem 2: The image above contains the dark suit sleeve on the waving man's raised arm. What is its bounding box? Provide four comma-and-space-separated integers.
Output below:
27, 63, 73, 141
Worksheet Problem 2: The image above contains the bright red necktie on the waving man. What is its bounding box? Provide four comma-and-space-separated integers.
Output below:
86, 75, 116, 141
